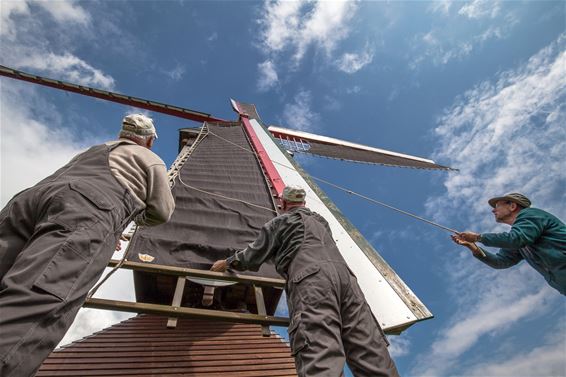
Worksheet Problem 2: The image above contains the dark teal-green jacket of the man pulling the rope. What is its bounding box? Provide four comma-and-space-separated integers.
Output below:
476, 208, 566, 295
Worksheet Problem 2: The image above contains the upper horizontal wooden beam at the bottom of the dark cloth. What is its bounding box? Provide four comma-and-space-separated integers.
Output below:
108, 260, 285, 288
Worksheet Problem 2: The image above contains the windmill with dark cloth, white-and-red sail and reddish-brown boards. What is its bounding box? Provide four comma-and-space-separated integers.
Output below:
0, 67, 450, 376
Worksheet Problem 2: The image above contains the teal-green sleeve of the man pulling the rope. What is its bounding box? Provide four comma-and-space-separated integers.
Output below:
480, 214, 544, 249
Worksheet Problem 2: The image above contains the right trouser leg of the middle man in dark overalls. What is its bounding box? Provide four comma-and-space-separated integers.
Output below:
342, 270, 399, 377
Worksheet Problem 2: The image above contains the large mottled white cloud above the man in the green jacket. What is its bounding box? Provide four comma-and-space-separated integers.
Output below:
429, 36, 566, 224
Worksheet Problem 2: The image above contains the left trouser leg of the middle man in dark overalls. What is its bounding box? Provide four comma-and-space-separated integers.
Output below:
289, 264, 346, 377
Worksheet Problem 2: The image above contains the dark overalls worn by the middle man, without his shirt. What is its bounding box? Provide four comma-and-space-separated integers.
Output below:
287, 213, 399, 377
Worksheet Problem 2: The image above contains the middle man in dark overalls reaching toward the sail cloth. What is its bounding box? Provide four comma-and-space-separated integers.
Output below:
212, 186, 399, 377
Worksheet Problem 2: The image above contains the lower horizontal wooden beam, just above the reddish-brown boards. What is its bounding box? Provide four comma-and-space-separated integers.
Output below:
83, 298, 289, 327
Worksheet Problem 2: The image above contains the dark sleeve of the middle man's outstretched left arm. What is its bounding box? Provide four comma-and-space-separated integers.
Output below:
226, 217, 282, 271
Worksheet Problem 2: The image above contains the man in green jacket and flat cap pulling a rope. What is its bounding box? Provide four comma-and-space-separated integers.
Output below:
452, 193, 566, 295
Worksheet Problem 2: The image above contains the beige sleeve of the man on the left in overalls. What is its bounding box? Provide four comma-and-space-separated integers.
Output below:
135, 164, 175, 226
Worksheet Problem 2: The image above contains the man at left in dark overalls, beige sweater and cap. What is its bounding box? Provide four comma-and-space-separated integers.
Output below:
0, 114, 175, 377
